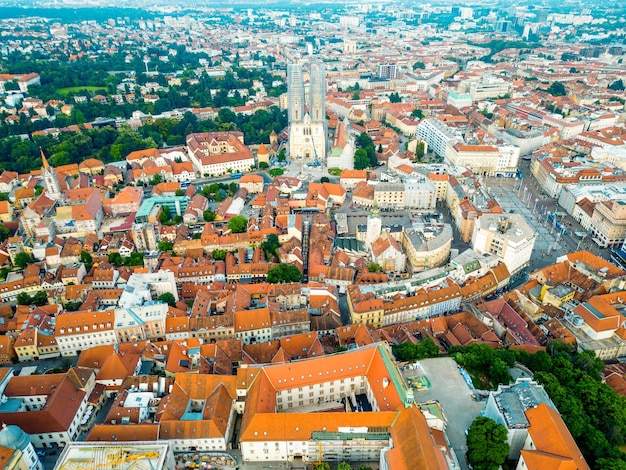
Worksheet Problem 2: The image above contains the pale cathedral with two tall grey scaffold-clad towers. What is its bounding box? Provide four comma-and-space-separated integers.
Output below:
287, 61, 328, 163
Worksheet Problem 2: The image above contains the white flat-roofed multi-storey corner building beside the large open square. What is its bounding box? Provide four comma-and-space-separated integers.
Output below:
472, 214, 536, 275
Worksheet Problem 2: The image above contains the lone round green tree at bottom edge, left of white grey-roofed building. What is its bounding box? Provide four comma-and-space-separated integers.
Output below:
467, 416, 509, 470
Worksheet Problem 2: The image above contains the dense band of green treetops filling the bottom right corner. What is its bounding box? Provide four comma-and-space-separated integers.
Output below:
448, 341, 626, 470
